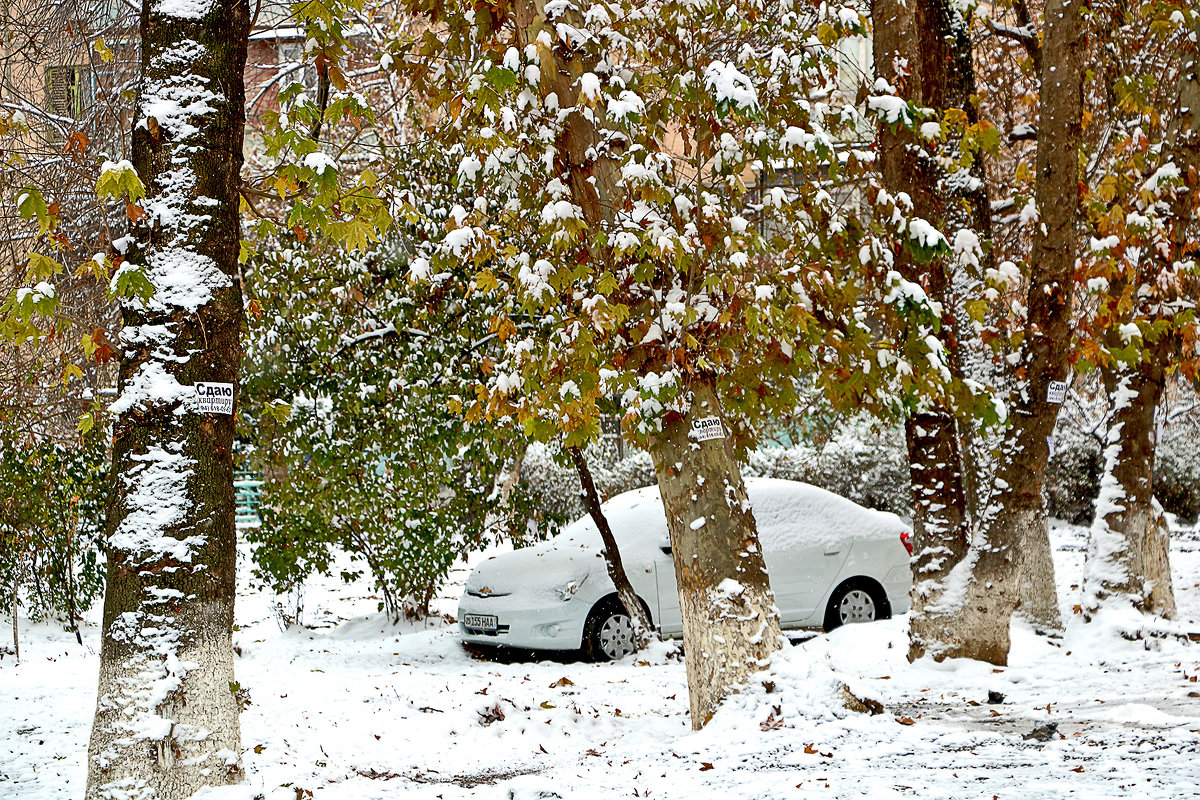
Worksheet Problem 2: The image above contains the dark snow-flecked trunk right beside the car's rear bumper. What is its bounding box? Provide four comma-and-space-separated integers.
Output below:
871, 0, 989, 660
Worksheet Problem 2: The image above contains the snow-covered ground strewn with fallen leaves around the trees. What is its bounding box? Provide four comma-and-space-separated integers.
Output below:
0, 525, 1200, 800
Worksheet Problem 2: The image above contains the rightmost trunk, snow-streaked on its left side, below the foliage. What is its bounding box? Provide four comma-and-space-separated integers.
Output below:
1082, 357, 1175, 618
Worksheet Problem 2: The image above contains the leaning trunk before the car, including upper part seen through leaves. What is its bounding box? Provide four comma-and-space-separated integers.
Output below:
514, 0, 782, 729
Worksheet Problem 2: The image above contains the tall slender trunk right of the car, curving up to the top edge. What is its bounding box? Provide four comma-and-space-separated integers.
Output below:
947, 0, 1085, 664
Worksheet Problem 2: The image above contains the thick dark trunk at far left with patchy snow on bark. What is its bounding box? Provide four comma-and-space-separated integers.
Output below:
86, 0, 250, 800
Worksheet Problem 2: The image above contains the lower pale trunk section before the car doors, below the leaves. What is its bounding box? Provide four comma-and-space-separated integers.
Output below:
650, 380, 782, 730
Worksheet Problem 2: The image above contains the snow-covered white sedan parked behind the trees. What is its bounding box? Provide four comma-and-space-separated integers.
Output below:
458, 479, 912, 660
